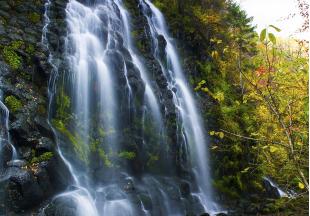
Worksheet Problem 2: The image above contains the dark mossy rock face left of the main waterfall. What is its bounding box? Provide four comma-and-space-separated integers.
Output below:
0, 0, 70, 215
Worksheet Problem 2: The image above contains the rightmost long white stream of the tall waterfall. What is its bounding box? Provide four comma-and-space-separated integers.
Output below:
140, 0, 218, 211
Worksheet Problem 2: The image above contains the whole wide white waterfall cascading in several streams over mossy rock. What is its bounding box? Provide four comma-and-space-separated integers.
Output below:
43, 0, 220, 216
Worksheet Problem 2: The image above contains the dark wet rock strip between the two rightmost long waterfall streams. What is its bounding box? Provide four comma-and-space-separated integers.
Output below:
126, 0, 189, 176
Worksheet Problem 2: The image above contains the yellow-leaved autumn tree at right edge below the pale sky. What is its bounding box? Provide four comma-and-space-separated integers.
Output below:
242, 26, 309, 191
